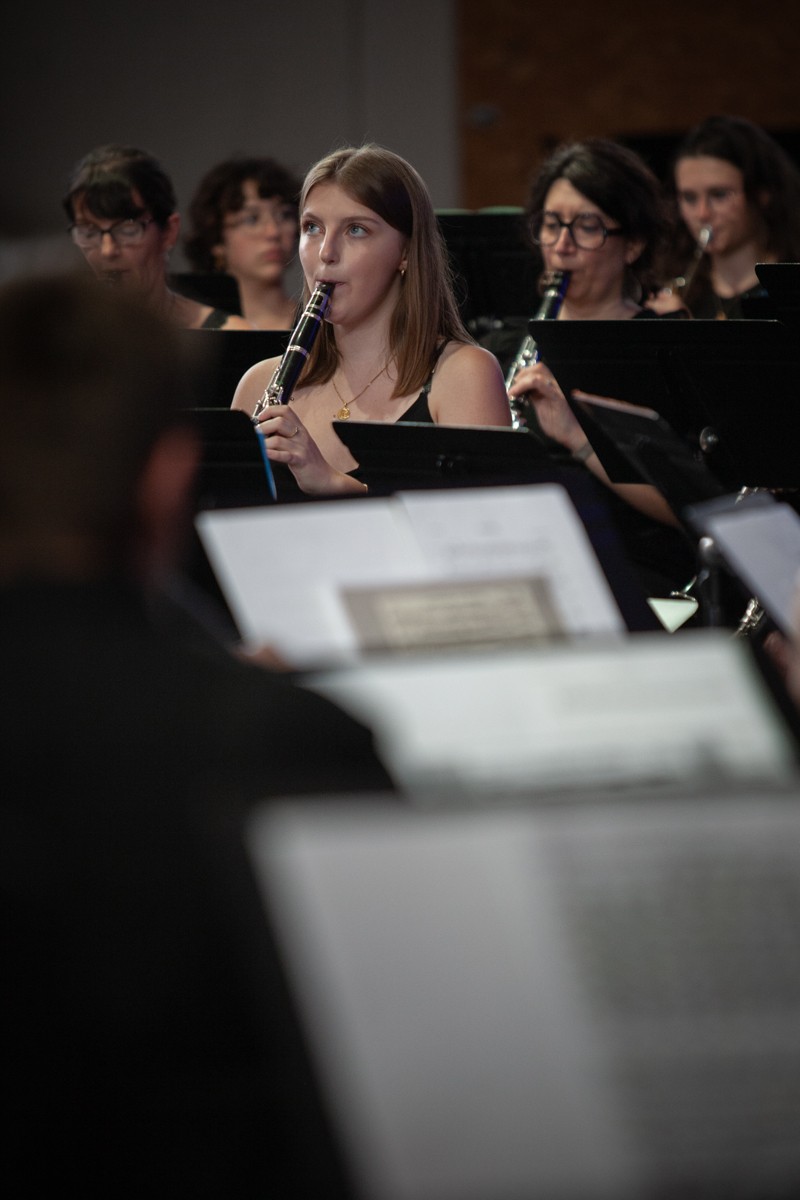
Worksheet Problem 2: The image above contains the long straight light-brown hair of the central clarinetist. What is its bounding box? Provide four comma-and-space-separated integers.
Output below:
300, 143, 473, 396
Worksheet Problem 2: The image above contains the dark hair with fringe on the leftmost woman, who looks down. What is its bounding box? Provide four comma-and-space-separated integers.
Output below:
62, 144, 178, 229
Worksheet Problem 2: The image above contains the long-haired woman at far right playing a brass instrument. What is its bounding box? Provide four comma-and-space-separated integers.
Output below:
664, 116, 800, 320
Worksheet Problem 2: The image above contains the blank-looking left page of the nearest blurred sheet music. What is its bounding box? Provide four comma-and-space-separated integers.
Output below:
253, 805, 639, 1200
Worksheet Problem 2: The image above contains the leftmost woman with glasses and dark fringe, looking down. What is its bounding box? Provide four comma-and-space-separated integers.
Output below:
64, 145, 249, 329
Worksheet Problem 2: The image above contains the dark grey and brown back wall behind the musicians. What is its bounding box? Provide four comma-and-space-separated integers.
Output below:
0, 0, 800, 276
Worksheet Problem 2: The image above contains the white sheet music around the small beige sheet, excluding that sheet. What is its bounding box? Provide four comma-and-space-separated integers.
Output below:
197, 485, 625, 667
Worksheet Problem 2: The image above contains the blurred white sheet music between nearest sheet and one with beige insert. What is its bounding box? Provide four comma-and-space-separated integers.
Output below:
309, 630, 795, 800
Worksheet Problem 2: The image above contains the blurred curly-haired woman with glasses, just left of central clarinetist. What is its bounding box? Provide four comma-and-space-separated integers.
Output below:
185, 157, 300, 329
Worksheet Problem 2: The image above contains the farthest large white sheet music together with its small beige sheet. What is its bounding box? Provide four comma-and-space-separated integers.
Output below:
197, 485, 625, 667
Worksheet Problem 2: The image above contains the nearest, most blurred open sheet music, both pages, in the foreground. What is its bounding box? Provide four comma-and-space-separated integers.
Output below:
247, 788, 800, 1200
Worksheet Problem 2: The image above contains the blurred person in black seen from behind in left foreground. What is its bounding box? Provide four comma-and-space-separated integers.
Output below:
0, 276, 390, 1196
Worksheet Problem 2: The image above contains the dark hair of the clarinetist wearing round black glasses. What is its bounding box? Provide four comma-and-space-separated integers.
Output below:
525, 138, 669, 295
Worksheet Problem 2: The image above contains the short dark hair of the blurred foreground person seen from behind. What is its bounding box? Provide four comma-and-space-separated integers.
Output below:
0, 272, 199, 562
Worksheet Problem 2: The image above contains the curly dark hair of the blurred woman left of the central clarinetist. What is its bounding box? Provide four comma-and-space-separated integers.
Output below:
184, 156, 300, 271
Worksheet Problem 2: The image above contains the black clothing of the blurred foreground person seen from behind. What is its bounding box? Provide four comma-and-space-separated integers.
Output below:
0, 582, 390, 1198
